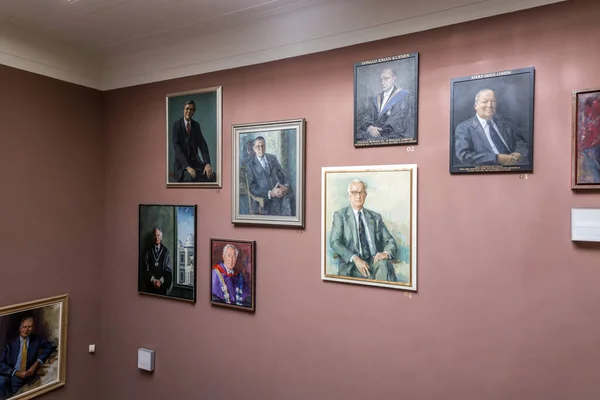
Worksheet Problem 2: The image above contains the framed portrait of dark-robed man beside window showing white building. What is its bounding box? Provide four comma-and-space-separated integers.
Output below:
138, 204, 197, 302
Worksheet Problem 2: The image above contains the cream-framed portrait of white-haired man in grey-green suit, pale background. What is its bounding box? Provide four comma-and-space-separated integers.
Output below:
321, 164, 417, 291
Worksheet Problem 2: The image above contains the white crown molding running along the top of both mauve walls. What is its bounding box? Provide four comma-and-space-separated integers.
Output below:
0, 0, 564, 90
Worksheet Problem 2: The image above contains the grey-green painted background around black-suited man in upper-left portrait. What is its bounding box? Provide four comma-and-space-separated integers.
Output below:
167, 91, 221, 182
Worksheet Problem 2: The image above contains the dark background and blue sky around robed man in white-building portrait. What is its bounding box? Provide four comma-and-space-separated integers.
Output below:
138, 205, 196, 300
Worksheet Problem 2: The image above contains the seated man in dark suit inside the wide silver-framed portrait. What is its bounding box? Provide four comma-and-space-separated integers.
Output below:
245, 136, 296, 216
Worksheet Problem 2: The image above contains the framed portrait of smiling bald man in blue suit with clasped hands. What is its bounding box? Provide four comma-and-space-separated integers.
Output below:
450, 67, 534, 173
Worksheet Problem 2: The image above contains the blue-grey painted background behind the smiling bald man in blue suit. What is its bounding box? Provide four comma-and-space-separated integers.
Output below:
451, 73, 533, 166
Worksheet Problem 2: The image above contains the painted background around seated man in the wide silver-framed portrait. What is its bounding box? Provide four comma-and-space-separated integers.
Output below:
237, 129, 299, 215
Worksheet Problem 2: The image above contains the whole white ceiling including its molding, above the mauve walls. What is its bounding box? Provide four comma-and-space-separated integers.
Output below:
0, 0, 563, 90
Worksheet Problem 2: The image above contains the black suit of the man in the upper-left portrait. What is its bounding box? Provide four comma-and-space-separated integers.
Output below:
172, 118, 212, 182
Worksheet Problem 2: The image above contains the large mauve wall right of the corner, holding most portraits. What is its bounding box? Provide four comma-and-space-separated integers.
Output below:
98, 0, 600, 400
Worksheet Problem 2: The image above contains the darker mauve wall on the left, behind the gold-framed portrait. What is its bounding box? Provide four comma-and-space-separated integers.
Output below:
0, 66, 103, 400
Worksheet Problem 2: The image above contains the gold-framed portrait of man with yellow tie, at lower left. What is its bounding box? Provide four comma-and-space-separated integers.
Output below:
0, 294, 68, 399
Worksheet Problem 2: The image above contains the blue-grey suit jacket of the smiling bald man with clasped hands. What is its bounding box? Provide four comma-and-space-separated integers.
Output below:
454, 115, 529, 166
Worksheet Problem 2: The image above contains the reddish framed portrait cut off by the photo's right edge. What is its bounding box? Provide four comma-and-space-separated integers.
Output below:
571, 88, 600, 189
